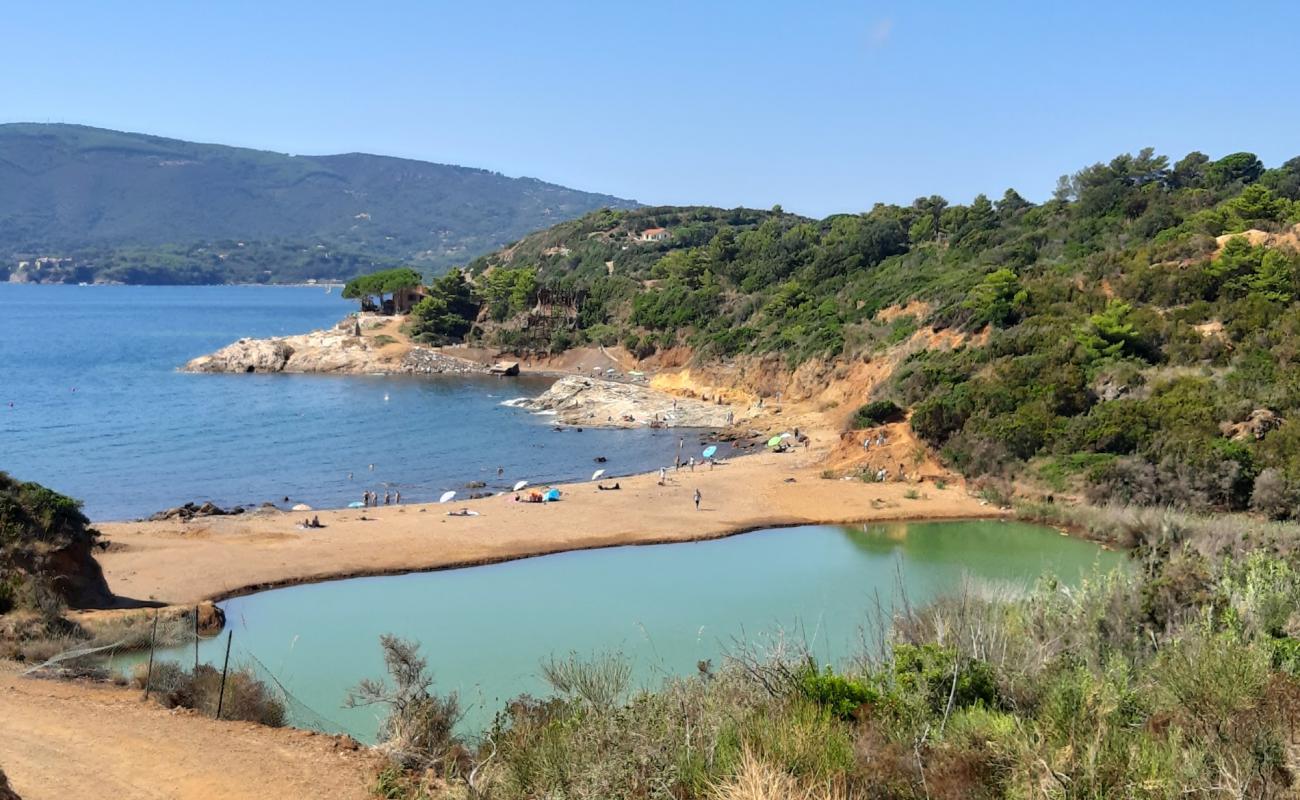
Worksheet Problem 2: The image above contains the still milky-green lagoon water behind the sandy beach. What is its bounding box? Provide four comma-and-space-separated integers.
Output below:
134, 522, 1123, 740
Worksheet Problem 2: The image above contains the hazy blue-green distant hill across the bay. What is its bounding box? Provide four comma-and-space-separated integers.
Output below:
0, 124, 636, 277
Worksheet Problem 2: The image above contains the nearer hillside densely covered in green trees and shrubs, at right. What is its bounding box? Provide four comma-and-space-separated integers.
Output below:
413, 151, 1300, 516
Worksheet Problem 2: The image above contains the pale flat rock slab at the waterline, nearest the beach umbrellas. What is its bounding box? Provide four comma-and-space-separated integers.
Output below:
514, 376, 733, 428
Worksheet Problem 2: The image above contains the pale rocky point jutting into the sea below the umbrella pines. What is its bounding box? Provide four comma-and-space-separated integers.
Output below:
181, 320, 488, 375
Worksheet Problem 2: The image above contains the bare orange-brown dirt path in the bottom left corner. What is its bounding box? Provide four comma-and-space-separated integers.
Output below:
0, 671, 373, 800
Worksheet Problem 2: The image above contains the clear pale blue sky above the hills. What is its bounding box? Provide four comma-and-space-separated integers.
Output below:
0, 0, 1300, 216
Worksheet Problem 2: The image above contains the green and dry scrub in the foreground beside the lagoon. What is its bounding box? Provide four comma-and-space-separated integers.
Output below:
358, 507, 1300, 800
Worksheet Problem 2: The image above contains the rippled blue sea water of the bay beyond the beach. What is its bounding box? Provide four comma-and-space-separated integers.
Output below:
0, 284, 693, 519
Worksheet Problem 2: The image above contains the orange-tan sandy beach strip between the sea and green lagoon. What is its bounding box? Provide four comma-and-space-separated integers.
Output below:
98, 441, 998, 604
